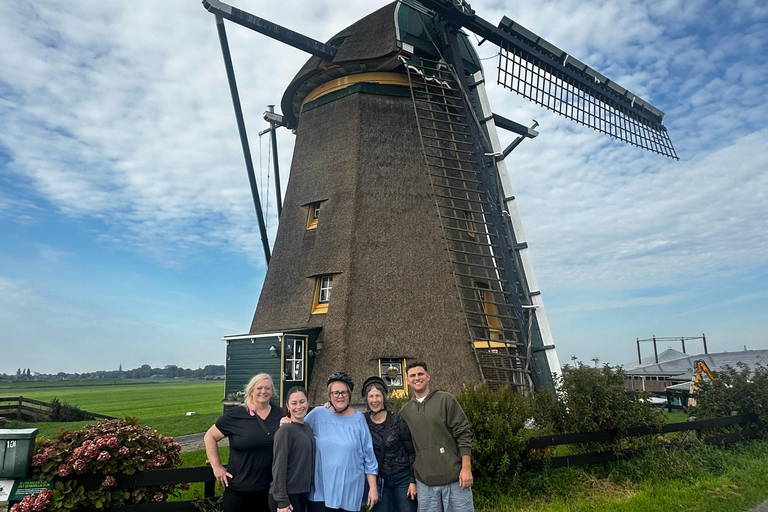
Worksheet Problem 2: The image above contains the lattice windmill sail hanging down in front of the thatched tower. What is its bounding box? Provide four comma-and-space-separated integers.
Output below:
406, 59, 533, 392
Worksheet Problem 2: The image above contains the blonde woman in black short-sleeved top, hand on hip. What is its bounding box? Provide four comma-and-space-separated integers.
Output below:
203, 373, 283, 512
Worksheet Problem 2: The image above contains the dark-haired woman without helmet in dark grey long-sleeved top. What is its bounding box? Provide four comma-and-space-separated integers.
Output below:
269, 386, 315, 512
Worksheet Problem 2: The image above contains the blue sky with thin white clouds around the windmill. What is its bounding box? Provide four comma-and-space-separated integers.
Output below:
0, 0, 768, 373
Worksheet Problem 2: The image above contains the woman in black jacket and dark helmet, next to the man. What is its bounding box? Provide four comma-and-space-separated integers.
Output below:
363, 377, 416, 512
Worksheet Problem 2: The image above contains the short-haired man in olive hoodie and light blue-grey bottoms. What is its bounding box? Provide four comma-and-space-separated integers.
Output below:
400, 361, 475, 512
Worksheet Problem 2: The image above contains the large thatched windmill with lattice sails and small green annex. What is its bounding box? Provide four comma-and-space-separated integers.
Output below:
203, 0, 677, 399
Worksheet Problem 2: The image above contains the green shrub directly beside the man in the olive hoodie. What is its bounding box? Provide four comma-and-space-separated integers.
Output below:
456, 386, 543, 479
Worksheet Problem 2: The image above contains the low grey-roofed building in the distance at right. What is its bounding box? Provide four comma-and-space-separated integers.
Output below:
623, 348, 768, 393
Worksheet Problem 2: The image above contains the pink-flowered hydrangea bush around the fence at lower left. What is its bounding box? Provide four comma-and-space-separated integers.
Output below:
15, 418, 182, 512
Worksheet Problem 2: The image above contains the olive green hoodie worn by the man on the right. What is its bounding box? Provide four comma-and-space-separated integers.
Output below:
400, 390, 472, 485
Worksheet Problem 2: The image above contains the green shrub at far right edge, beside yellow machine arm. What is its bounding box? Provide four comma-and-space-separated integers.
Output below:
689, 363, 768, 431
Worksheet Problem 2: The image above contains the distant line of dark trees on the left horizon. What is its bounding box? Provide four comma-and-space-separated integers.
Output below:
0, 364, 224, 381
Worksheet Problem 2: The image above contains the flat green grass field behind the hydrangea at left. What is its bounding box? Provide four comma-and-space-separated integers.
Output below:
0, 379, 224, 437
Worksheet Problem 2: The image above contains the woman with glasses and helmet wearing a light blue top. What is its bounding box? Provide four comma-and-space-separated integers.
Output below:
306, 372, 379, 512
